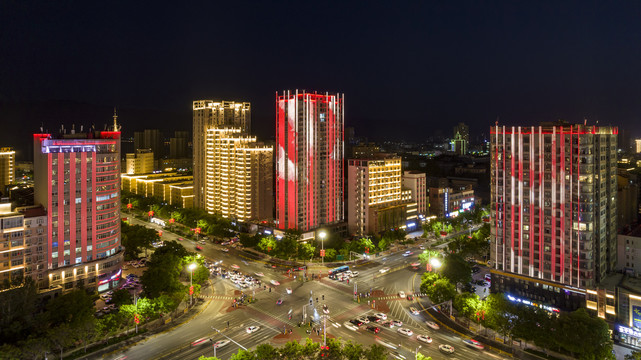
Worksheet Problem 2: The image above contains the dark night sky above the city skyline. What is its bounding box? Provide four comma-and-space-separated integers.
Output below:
0, 1, 641, 158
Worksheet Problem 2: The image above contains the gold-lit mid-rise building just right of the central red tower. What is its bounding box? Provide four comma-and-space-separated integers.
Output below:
347, 153, 418, 235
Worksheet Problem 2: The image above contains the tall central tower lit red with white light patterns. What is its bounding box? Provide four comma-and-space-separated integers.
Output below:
276, 90, 344, 231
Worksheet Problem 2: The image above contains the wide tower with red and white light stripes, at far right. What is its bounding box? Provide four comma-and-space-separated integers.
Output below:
490, 122, 618, 309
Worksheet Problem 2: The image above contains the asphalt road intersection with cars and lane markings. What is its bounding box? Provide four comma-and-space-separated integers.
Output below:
112, 220, 503, 359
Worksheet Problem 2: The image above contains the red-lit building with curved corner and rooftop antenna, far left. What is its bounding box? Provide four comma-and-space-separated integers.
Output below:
34, 121, 123, 291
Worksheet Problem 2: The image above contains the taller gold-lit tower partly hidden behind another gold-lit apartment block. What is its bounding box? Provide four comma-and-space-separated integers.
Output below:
193, 100, 251, 209
